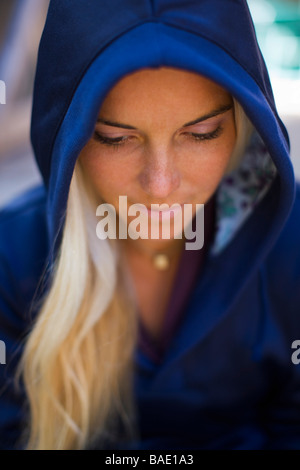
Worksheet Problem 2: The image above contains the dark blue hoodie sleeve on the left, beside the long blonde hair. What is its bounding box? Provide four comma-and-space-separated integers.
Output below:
0, 185, 47, 449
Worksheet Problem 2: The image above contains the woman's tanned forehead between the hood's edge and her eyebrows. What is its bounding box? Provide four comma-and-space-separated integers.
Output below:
100, 67, 231, 125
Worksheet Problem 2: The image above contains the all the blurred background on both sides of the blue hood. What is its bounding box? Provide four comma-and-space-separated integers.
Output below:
0, 0, 300, 206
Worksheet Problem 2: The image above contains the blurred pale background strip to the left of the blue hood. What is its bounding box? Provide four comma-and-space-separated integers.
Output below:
0, 0, 49, 206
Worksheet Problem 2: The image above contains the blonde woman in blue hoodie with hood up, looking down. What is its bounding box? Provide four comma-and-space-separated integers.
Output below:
0, 0, 300, 449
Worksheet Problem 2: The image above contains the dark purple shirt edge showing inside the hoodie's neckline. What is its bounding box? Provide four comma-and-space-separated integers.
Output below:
138, 197, 215, 363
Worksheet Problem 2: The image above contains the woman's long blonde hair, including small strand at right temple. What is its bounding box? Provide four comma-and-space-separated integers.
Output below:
20, 100, 252, 449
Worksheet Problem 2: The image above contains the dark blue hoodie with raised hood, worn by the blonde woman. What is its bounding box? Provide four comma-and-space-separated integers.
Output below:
0, 0, 300, 449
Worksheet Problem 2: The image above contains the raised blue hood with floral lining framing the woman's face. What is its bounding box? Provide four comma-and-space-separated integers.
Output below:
31, 0, 295, 264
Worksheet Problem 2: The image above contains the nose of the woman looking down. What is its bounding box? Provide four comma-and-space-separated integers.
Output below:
139, 146, 181, 198
